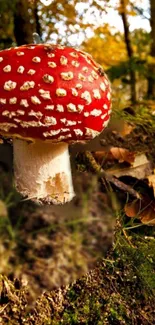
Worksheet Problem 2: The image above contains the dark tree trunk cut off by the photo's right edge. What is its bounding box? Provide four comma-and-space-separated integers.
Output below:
147, 0, 155, 99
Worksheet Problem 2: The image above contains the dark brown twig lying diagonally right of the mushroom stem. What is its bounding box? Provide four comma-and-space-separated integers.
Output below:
84, 151, 141, 199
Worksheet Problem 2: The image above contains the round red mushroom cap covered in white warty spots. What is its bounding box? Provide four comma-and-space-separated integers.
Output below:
0, 44, 111, 142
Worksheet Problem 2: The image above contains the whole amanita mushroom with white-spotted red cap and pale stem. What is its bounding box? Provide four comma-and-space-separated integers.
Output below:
0, 44, 111, 204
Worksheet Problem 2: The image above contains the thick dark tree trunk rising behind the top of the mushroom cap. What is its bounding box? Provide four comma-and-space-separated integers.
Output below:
14, 0, 34, 45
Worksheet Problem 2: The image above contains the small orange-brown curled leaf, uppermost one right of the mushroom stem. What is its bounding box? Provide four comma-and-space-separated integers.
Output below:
110, 147, 135, 164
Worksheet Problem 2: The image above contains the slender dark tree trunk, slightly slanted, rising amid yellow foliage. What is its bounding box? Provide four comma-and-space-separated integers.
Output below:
120, 0, 136, 103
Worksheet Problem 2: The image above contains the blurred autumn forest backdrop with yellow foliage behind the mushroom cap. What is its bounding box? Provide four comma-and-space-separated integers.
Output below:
0, 0, 155, 105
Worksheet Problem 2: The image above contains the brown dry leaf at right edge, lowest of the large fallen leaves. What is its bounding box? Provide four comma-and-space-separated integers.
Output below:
124, 196, 155, 226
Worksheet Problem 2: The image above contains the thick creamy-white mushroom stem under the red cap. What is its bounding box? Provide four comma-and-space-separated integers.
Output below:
13, 139, 74, 204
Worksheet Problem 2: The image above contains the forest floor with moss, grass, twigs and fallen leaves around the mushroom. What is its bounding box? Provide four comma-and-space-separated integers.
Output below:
0, 103, 155, 325
